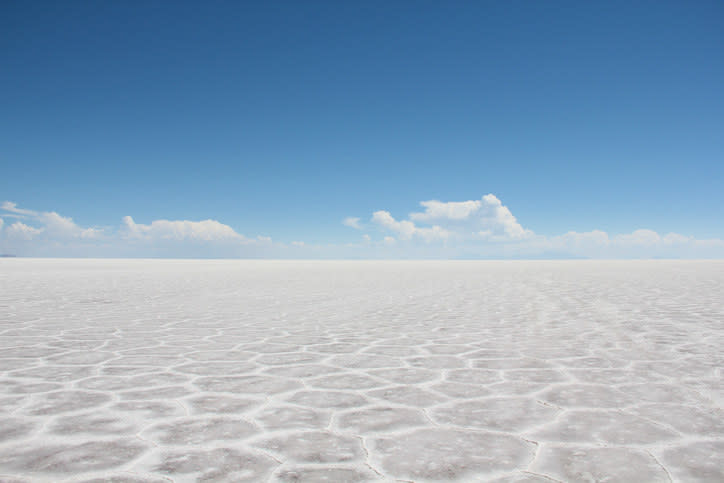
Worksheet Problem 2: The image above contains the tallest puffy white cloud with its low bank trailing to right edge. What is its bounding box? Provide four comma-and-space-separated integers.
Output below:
342, 194, 724, 258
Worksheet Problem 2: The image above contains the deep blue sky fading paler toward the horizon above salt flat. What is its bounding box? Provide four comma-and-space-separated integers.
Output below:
0, 1, 724, 258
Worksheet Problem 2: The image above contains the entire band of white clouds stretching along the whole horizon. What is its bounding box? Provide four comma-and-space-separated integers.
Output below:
0, 198, 724, 259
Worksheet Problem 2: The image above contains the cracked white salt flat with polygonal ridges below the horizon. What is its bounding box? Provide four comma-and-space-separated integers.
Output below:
0, 259, 724, 482
